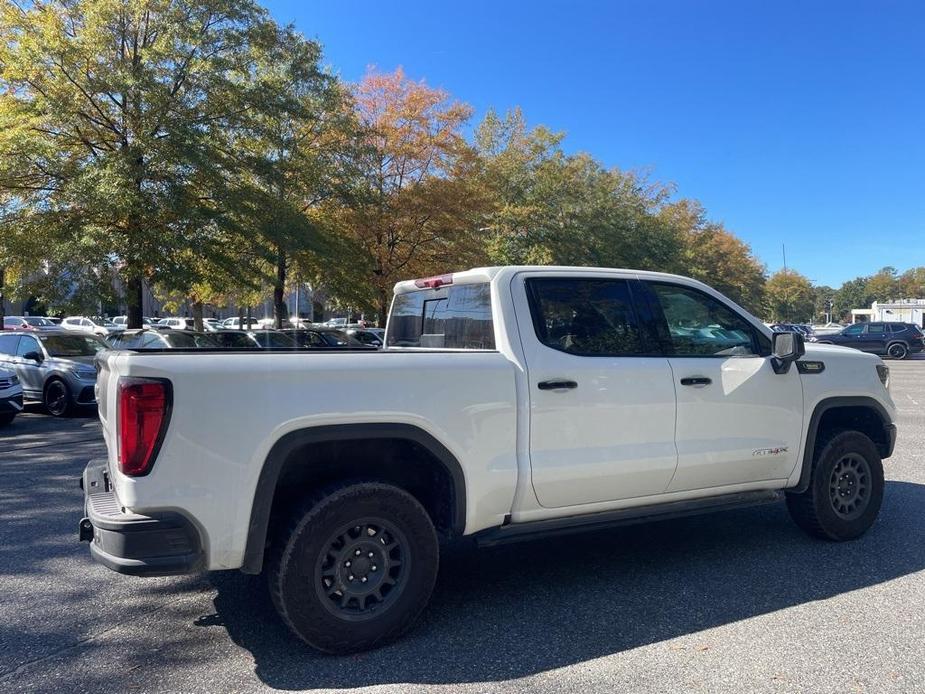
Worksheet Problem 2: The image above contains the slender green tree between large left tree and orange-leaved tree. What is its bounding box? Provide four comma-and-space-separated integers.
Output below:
229, 34, 359, 328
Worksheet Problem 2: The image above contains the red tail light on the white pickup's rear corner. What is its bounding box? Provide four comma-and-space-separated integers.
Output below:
118, 378, 172, 477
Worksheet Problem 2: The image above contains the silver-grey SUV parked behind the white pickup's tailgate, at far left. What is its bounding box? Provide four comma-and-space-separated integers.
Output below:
0, 330, 108, 417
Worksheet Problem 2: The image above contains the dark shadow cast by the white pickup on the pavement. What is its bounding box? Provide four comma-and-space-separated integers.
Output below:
204, 482, 925, 689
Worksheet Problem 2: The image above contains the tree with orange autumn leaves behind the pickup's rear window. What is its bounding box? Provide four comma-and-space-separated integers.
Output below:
325, 68, 483, 324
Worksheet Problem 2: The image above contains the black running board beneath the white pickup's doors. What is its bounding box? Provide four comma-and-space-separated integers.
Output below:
474, 490, 784, 547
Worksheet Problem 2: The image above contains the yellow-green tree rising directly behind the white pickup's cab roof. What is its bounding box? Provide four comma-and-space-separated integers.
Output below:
475, 110, 681, 269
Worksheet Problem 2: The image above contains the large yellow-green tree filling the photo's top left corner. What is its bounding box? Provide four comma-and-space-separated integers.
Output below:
0, 0, 336, 327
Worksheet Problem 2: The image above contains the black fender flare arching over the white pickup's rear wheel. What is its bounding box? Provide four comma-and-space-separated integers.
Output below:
241, 424, 466, 574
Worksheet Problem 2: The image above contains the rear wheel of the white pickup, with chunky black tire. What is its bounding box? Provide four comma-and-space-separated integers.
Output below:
269, 483, 439, 653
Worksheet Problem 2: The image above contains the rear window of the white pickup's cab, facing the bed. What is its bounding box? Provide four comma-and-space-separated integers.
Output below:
386, 284, 495, 349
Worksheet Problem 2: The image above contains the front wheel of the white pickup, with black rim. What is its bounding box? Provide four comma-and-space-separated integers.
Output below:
787, 431, 883, 542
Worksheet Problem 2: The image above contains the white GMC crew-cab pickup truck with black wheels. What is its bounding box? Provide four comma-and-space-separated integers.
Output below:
80, 267, 896, 653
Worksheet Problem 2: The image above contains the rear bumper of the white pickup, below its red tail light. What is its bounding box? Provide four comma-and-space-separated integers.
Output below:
78, 459, 205, 576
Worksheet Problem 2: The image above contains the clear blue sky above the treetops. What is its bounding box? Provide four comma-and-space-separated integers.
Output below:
266, 0, 925, 286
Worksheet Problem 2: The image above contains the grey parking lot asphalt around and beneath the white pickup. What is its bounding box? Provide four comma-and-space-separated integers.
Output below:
0, 359, 925, 693
